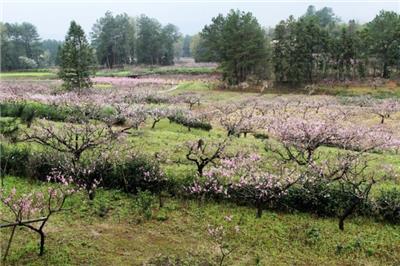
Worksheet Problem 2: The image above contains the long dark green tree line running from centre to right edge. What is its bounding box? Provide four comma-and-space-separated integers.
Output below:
192, 6, 400, 85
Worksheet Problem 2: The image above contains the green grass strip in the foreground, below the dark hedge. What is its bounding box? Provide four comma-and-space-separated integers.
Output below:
1, 177, 400, 265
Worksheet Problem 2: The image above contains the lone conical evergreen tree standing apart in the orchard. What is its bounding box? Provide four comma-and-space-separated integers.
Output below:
58, 21, 95, 90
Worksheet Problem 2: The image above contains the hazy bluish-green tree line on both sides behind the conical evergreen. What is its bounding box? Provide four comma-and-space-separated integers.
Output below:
0, 12, 185, 70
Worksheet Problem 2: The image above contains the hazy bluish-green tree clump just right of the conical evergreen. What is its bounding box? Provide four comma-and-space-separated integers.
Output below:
90, 12, 181, 68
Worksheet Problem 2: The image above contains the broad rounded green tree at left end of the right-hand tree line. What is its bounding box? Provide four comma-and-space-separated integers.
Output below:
201, 10, 267, 84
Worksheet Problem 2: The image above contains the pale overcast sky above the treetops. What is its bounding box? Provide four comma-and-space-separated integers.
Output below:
0, 0, 400, 40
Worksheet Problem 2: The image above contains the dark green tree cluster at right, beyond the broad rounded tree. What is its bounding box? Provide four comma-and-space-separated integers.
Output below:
272, 7, 400, 83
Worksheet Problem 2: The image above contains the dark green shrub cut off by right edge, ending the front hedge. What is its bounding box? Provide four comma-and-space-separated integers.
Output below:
375, 188, 400, 224
